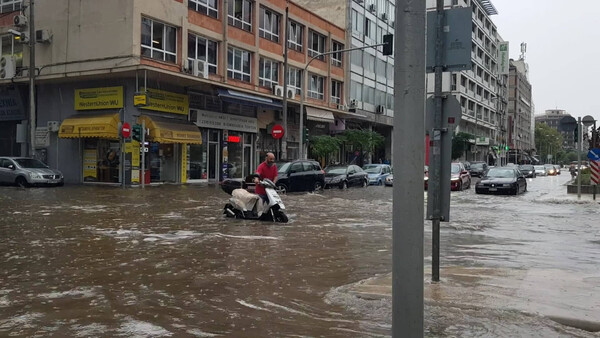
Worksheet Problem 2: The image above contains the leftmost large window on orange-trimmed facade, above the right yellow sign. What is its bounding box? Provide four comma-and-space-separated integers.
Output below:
142, 18, 177, 63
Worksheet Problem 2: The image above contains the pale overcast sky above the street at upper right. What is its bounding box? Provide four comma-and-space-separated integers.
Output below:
491, 0, 600, 120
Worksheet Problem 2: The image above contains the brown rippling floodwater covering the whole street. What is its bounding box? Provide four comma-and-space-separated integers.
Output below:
0, 173, 600, 337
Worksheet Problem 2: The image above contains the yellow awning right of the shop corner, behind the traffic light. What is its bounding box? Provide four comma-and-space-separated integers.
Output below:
138, 115, 202, 144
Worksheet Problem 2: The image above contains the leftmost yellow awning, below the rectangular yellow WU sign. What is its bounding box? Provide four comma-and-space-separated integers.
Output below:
58, 113, 119, 140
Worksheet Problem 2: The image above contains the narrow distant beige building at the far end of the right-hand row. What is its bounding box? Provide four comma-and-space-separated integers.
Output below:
508, 59, 535, 163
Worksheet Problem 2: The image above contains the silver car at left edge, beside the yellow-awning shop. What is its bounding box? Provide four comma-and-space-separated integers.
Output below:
0, 157, 64, 187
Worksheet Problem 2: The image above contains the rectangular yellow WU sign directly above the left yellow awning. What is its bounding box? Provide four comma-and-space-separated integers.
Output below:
75, 86, 123, 110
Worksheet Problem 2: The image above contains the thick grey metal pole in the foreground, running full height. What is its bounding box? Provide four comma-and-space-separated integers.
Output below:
392, 0, 426, 337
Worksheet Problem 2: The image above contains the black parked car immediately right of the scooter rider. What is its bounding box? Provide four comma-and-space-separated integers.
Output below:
276, 160, 325, 193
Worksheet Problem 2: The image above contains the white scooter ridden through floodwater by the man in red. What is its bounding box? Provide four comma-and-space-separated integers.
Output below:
223, 179, 288, 223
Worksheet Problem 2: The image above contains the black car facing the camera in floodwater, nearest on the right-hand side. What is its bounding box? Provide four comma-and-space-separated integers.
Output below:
475, 167, 527, 195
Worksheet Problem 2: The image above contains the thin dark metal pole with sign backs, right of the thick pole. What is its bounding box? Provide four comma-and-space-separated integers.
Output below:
427, 0, 446, 282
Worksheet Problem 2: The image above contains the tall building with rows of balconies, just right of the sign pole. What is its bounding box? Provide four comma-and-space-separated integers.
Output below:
427, 0, 505, 164
